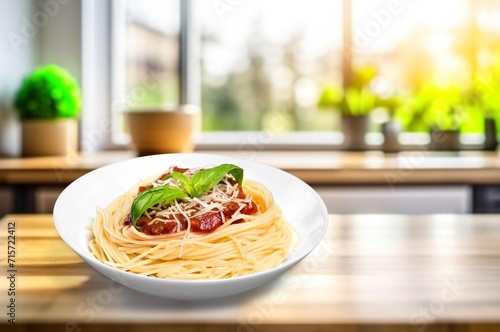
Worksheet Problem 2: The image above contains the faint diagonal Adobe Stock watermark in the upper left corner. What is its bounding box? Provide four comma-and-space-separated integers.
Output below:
7, 0, 71, 53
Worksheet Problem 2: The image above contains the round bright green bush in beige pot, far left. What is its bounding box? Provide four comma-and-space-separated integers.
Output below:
14, 65, 81, 156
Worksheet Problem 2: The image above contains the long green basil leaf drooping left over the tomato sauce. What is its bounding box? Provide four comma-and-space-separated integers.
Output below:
130, 186, 187, 227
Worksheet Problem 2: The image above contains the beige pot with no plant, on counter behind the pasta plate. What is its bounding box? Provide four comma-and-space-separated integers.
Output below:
126, 105, 201, 155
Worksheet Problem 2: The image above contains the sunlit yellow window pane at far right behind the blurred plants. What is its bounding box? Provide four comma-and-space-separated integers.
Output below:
353, 0, 500, 132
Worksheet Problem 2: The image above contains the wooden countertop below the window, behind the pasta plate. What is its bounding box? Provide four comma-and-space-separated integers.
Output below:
0, 150, 500, 185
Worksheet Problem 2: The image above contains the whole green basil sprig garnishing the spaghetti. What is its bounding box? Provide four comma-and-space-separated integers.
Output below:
130, 164, 243, 228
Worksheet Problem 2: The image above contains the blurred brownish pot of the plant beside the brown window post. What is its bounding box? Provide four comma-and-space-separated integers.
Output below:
342, 115, 369, 151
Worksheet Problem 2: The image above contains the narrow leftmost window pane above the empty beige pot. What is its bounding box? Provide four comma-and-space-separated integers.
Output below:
126, 0, 180, 107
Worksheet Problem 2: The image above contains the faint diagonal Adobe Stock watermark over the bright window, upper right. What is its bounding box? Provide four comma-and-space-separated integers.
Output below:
353, 0, 403, 48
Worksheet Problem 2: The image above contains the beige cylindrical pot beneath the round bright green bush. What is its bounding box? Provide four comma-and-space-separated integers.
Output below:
21, 119, 78, 157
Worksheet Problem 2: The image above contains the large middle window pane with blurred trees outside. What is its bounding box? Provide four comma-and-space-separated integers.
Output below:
193, 0, 342, 132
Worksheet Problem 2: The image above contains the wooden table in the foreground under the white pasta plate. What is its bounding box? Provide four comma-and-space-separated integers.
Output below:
0, 215, 500, 332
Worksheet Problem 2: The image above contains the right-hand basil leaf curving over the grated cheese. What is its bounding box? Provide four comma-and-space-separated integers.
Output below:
191, 164, 243, 197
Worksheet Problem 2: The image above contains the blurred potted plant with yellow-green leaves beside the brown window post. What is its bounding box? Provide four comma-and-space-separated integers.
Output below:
318, 67, 377, 150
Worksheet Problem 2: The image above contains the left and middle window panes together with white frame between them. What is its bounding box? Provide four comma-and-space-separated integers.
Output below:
112, 0, 342, 145
